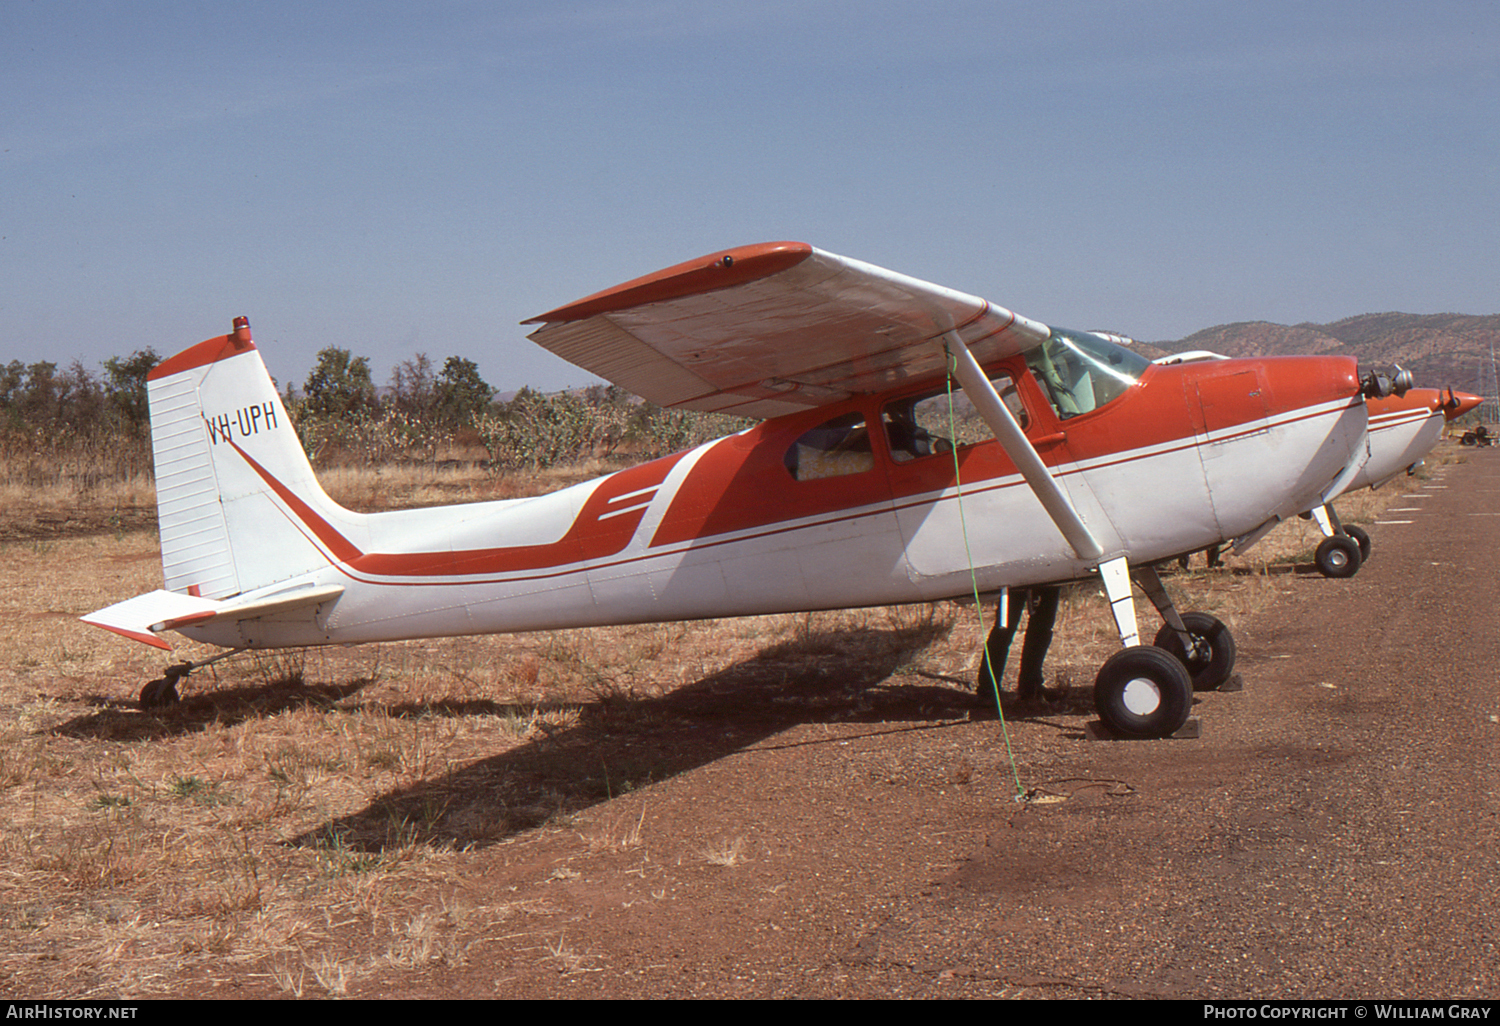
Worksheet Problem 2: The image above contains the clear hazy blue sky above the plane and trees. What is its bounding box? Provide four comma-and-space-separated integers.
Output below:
0, 0, 1500, 390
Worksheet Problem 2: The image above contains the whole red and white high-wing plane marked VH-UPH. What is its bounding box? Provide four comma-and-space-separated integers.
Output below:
84, 243, 1398, 737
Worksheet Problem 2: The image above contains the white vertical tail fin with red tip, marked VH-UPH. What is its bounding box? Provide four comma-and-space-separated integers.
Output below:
147, 317, 365, 599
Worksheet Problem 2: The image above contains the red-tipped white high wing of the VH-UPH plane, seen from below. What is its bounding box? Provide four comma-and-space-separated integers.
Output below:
524, 242, 1049, 417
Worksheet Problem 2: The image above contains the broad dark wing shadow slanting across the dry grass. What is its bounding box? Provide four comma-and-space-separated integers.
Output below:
291, 624, 996, 852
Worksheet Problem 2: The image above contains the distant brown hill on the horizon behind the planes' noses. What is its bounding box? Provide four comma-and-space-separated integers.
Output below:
1140, 314, 1500, 395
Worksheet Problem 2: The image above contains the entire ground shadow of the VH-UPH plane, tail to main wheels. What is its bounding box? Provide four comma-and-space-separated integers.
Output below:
51, 623, 1088, 854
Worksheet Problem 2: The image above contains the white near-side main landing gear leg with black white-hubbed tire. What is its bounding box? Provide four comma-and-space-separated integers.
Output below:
1094, 557, 1193, 738
